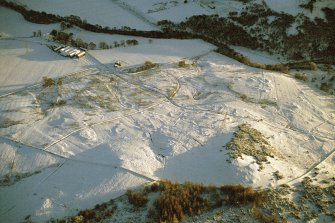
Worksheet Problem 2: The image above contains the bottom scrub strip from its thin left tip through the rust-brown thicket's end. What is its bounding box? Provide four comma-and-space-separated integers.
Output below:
52, 180, 265, 223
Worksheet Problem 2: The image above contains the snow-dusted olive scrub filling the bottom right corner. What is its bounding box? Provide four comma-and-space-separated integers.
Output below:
260, 177, 335, 222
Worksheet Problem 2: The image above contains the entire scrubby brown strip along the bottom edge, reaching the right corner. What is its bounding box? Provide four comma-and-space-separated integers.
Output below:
47, 178, 335, 223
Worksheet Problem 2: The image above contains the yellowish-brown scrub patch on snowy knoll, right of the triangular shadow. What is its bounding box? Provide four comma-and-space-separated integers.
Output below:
226, 124, 274, 170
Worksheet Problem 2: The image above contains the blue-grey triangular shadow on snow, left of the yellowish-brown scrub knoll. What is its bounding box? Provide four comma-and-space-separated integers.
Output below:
155, 134, 252, 184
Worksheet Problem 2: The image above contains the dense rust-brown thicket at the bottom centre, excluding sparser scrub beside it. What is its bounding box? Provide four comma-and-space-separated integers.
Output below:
155, 181, 265, 223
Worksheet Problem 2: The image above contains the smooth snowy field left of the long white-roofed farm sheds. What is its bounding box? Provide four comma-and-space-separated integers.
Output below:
0, 38, 92, 94
